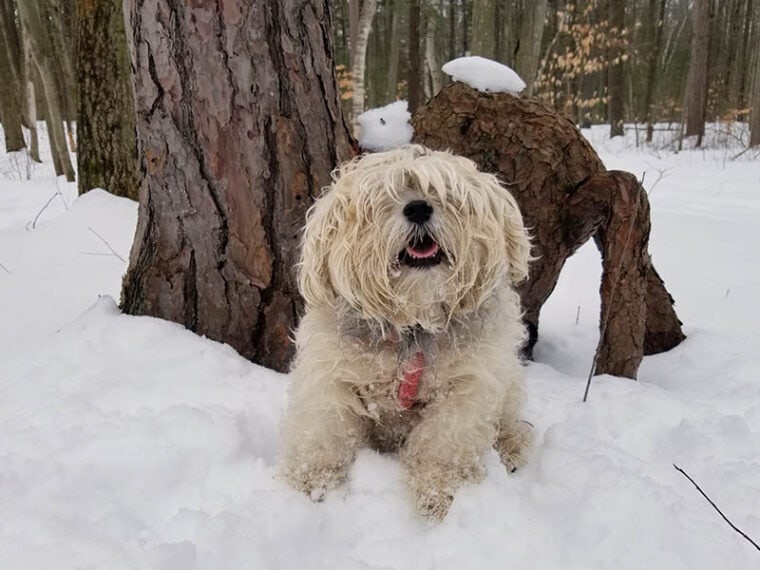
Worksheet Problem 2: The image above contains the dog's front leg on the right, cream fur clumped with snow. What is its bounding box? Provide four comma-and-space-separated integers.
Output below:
401, 368, 501, 519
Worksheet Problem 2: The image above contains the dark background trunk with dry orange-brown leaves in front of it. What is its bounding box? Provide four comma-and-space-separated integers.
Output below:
607, 0, 625, 138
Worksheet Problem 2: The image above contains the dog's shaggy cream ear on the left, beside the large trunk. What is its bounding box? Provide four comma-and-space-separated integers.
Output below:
298, 189, 344, 306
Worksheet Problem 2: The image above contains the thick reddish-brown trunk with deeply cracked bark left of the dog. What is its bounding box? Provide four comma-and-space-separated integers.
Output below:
122, 0, 353, 370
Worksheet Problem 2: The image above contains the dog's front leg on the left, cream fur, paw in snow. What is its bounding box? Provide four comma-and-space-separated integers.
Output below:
280, 371, 366, 501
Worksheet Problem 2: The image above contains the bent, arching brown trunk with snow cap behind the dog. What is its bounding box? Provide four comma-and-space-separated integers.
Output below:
412, 83, 685, 378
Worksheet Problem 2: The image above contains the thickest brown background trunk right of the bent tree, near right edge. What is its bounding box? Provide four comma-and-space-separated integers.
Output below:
684, 0, 712, 146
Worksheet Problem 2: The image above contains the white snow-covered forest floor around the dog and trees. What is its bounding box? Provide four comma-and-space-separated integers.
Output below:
0, 122, 760, 570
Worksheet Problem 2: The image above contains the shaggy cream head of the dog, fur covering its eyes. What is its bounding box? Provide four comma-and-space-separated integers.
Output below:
299, 145, 530, 331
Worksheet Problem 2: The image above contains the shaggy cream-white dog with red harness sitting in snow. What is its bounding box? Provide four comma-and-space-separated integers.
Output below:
281, 145, 532, 518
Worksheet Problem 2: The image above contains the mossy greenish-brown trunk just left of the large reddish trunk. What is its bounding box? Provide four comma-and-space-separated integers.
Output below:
77, 0, 139, 200
